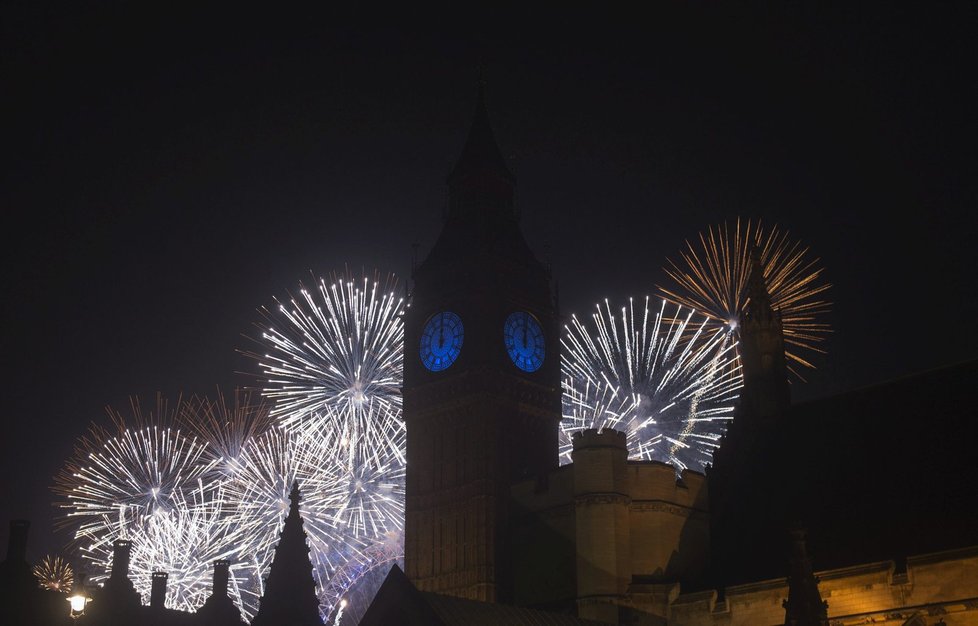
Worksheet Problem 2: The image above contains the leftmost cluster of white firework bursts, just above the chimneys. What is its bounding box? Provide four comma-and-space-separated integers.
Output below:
54, 396, 231, 610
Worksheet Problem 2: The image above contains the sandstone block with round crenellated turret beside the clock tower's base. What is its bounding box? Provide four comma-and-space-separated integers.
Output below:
511, 430, 709, 623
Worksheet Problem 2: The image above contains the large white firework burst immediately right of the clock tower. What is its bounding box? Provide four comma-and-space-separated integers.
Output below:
560, 298, 741, 472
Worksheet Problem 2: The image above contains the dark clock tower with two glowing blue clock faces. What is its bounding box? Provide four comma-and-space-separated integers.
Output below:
403, 86, 561, 602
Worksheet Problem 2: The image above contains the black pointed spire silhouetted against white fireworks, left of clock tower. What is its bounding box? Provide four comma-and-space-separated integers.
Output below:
251, 481, 323, 626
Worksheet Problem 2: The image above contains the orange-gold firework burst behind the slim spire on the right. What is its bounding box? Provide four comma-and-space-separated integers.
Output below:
659, 220, 831, 378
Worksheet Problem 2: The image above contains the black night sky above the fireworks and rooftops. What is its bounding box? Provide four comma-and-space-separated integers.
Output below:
0, 2, 978, 558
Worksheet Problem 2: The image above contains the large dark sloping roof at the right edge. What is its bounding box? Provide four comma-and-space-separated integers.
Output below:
711, 361, 978, 584
